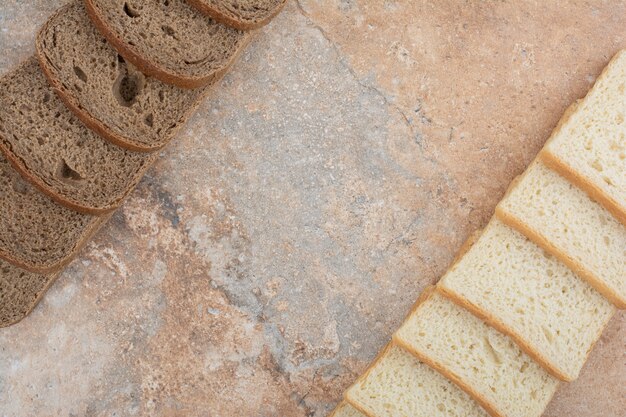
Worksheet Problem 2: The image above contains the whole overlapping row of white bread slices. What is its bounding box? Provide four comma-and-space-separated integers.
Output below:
332, 50, 626, 417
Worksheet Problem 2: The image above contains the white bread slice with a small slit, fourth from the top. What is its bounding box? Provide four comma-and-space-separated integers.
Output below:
393, 288, 559, 417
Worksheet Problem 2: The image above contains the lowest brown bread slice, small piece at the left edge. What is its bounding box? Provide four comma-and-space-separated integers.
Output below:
0, 260, 58, 327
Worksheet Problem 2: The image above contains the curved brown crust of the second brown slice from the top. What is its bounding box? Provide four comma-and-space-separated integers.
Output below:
84, 0, 250, 89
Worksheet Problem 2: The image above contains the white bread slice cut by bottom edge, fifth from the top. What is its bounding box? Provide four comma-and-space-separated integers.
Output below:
345, 344, 487, 417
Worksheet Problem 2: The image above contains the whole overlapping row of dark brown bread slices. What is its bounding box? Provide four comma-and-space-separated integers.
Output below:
0, 0, 284, 327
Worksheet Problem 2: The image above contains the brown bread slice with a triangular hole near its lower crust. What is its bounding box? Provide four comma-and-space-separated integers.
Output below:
0, 58, 157, 214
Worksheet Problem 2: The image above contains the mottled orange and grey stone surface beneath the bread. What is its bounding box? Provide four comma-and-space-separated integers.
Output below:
0, 0, 626, 417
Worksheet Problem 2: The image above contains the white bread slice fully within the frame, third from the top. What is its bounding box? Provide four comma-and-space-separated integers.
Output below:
437, 217, 615, 381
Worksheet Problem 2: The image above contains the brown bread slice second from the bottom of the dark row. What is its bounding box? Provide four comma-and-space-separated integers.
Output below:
0, 153, 110, 273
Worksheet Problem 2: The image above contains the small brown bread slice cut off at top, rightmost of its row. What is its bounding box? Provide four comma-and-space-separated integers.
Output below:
187, 0, 286, 30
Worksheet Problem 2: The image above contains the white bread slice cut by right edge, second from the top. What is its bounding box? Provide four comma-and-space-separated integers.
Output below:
496, 161, 626, 309
